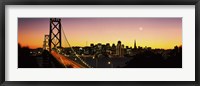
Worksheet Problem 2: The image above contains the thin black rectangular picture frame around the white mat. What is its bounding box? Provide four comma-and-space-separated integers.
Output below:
0, 0, 200, 86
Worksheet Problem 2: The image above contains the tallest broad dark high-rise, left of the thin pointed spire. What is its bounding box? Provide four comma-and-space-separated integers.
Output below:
116, 41, 124, 57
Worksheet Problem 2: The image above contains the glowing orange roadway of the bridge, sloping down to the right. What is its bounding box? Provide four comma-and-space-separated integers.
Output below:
51, 50, 85, 68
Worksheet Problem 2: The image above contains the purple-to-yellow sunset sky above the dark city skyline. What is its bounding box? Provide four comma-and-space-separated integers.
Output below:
18, 18, 182, 49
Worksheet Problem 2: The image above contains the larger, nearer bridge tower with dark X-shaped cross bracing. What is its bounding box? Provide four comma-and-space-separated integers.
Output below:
49, 18, 62, 51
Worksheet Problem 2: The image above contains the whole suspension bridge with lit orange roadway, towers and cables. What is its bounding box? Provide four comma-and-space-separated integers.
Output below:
43, 18, 91, 68
